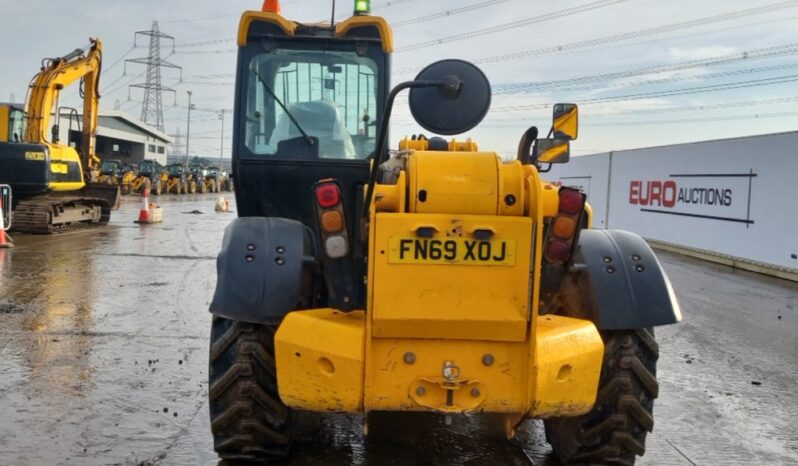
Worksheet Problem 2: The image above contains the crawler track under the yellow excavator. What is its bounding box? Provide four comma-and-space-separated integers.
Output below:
12, 196, 111, 234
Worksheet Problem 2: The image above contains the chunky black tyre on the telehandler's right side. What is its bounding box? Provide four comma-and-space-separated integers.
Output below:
544, 329, 659, 466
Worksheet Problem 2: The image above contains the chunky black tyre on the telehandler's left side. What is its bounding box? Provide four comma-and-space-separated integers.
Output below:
208, 317, 292, 464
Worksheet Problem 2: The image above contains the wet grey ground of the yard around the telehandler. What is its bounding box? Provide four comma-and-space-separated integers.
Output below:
0, 195, 798, 466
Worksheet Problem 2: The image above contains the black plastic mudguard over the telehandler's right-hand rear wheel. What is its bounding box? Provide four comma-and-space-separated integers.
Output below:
574, 230, 682, 330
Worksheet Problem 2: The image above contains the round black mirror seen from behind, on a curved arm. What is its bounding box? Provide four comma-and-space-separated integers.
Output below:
410, 60, 490, 136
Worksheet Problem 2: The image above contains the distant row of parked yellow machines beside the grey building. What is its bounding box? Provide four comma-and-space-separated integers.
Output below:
100, 159, 233, 196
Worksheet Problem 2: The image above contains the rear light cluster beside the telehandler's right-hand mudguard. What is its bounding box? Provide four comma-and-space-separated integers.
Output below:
543, 187, 585, 265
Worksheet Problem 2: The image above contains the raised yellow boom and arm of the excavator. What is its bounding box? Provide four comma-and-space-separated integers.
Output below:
25, 39, 103, 179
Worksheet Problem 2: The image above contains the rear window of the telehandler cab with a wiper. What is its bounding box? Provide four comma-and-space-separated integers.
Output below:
240, 49, 379, 160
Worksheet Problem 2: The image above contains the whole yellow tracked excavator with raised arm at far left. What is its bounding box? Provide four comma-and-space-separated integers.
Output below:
0, 39, 120, 233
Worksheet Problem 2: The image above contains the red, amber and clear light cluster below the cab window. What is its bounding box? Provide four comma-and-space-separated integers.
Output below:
313, 180, 349, 259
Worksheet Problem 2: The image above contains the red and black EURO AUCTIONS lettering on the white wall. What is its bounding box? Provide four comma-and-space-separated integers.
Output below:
629, 170, 757, 225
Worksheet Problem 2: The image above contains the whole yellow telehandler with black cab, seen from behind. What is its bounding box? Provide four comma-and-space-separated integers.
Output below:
209, 0, 681, 464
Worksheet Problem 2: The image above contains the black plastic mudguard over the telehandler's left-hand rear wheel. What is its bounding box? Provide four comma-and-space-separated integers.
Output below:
210, 217, 313, 324
